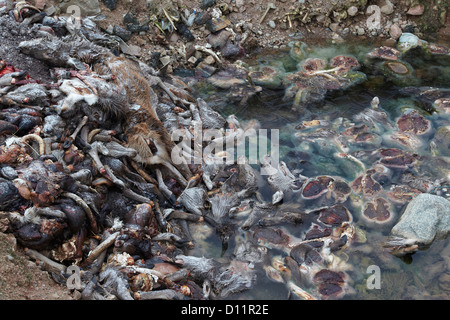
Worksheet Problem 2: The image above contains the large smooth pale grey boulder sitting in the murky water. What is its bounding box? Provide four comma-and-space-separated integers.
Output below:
391, 193, 450, 246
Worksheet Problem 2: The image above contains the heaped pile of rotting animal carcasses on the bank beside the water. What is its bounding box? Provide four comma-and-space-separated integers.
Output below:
0, 4, 353, 299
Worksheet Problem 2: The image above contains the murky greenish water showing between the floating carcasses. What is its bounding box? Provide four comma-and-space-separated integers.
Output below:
181, 38, 450, 300
